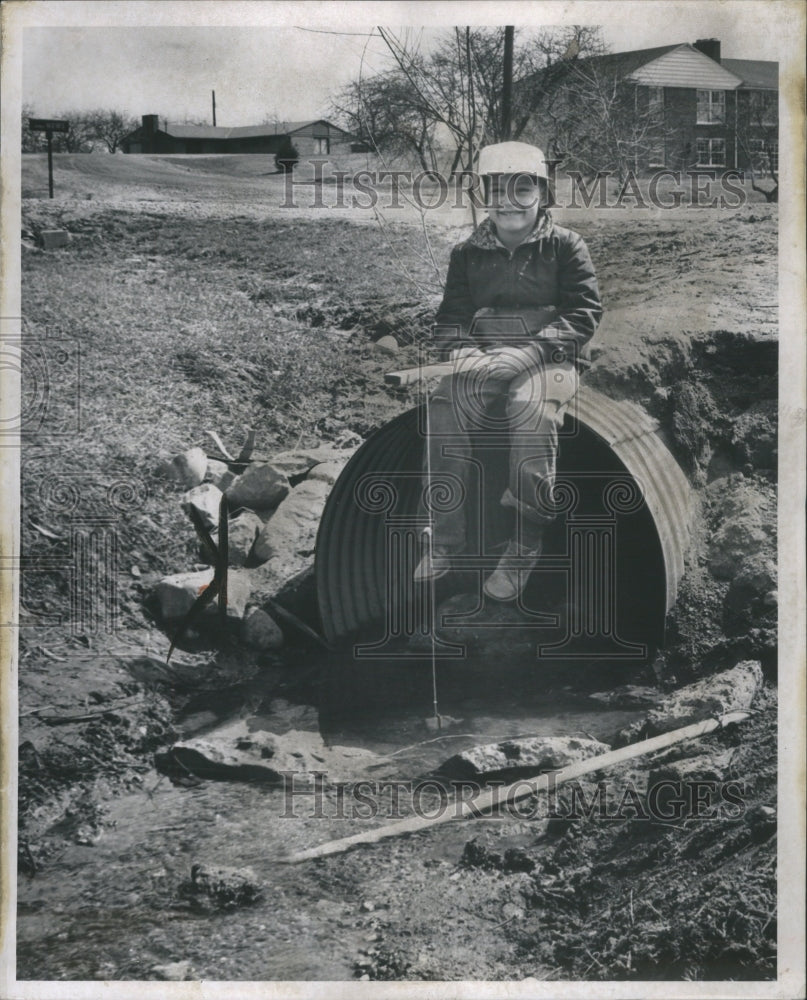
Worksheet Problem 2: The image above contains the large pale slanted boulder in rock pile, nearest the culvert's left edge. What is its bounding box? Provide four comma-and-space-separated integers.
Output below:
253, 479, 331, 564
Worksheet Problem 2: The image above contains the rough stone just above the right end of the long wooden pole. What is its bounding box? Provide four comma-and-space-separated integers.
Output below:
616, 660, 762, 746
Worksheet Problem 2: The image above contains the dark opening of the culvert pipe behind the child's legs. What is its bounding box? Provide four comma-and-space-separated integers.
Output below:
316, 393, 680, 724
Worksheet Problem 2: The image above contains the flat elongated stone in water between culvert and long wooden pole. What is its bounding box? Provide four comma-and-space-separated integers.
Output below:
438, 736, 610, 778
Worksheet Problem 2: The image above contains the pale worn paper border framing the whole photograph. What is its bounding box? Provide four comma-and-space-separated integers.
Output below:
0, 0, 807, 1000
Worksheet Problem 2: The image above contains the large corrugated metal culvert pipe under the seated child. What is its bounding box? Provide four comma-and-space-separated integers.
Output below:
316, 386, 691, 663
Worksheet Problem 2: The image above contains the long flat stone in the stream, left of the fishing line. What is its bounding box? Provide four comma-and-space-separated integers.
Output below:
155, 719, 397, 788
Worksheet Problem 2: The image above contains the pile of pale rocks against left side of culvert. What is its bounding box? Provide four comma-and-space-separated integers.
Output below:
155, 438, 357, 650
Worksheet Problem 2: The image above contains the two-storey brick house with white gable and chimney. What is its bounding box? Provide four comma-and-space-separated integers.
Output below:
530, 38, 778, 173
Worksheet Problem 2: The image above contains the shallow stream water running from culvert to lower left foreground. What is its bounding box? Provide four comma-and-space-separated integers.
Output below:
17, 676, 643, 980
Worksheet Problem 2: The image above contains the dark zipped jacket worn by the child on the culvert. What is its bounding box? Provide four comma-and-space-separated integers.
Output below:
434, 212, 602, 367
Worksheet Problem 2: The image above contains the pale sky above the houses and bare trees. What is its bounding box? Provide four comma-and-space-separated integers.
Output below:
17, 0, 781, 125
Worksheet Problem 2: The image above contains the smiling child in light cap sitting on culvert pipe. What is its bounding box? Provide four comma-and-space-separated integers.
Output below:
415, 142, 602, 601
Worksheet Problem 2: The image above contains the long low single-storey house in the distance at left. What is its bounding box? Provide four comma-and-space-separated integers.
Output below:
121, 115, 356, 156
